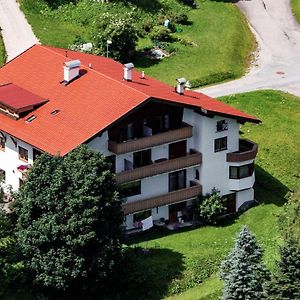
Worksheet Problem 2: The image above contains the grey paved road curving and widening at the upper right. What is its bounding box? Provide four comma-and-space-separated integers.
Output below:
197, 0, 300, 97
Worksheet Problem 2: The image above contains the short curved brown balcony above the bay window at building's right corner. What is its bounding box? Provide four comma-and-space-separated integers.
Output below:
227, 139, 258, 162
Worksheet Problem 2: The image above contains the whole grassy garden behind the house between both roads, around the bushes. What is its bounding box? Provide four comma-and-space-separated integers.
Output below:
19, 0, 254, 86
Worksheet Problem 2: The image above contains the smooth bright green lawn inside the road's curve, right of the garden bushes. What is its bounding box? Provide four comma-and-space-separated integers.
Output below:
137, 1, 253, 84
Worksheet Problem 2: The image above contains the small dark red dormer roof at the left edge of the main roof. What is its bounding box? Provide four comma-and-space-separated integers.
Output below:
0, 83, 47, 112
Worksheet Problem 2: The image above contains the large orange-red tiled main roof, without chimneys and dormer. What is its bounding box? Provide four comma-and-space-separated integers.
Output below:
0, 45, 259, 155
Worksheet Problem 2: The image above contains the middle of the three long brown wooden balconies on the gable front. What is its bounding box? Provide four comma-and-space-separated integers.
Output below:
116, 150, 202, 183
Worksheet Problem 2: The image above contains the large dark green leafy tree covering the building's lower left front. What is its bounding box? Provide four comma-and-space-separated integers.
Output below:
15, 146, 123, 291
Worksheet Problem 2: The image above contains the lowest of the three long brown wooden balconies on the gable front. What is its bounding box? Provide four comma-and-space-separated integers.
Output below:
123, 181, 202, 215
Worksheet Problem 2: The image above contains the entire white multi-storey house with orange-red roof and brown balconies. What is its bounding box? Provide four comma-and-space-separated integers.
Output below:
0, 45, 259, 229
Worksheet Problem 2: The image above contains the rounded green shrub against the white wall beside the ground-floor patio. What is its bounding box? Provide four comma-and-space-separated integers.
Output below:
199, 188, 226, 223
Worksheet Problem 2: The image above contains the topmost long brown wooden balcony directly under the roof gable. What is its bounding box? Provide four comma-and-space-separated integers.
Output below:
108, 124, 193, 154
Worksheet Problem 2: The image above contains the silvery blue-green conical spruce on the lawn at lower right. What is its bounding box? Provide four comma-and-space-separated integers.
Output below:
220, 226, 268, 300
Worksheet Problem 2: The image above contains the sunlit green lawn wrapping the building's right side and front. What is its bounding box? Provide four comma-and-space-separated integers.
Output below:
125, 91, 300, 300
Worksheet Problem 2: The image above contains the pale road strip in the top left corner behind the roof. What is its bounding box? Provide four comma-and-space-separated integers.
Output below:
0, 0, 38, 61
